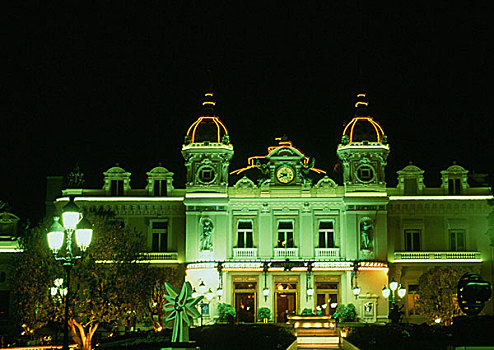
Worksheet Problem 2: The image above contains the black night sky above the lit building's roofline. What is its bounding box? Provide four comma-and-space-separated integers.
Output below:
0, 1, 494, 221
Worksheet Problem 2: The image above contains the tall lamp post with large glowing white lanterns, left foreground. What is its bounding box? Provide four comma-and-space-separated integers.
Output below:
47, 197, 93, 350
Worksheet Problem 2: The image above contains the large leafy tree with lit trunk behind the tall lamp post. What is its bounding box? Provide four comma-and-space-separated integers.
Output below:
14, 210, 148, 350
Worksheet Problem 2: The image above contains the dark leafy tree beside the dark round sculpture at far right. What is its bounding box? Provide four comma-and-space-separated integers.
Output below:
418, 266, 466, 325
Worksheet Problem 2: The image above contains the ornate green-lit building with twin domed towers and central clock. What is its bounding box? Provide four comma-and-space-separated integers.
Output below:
45, 94, 493, 322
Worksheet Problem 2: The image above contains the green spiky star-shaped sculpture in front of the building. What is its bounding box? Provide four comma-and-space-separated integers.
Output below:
163, 282, 203, 343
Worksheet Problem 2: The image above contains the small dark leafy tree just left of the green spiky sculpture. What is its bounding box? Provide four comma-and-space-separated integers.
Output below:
141, 265, 185, 332
